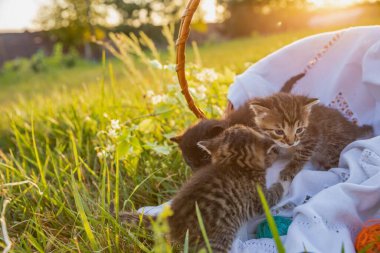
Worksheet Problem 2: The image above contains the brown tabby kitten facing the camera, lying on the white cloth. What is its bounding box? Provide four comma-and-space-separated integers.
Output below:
249, 93, 373, 180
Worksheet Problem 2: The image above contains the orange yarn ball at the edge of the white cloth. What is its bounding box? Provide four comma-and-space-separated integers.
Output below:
355, 219, 380, 253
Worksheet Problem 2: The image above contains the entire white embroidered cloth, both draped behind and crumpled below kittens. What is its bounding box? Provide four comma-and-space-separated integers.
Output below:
139, 26, 380, 253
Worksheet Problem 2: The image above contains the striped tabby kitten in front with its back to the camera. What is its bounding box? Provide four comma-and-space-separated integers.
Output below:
121, 125, 289, 252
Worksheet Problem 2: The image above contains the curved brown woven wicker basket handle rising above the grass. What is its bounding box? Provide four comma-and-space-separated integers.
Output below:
176, 0, 206, 119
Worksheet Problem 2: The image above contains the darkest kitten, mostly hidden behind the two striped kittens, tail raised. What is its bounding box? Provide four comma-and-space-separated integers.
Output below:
170, 73, 305, 171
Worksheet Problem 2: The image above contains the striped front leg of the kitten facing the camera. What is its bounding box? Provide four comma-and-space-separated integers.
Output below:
280, 140, 316, 181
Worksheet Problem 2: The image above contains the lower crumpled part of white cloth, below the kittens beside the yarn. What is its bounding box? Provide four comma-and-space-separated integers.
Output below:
231, 137, 380, 253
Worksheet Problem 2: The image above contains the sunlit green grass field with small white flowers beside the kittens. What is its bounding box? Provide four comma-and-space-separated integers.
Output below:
0, 18, 378, 252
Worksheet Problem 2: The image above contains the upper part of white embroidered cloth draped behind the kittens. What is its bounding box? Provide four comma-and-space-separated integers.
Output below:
228, 26, 380, 134
